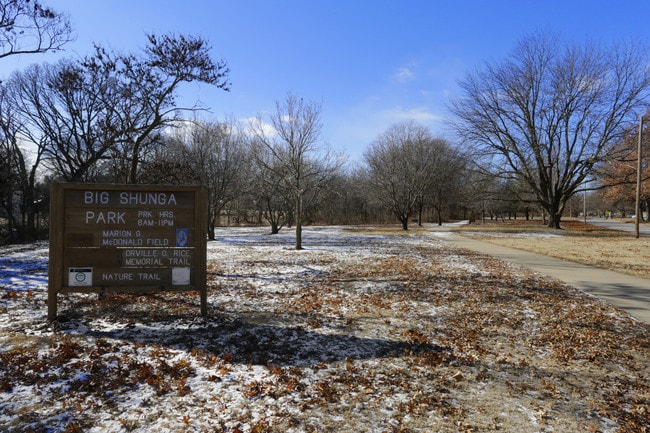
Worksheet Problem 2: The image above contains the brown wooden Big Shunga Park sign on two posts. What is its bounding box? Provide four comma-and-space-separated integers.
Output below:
48, 183, 207, 320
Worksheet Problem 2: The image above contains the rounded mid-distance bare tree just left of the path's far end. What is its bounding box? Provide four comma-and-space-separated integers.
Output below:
364, 121, 438, 230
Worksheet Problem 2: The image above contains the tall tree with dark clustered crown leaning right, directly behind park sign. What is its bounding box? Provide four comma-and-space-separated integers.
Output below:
83, 34, 230, 183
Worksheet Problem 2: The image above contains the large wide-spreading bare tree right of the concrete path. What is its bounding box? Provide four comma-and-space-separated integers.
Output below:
451, 34, 650, 228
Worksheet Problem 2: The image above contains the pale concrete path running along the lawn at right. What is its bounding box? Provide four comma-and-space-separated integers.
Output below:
444, 233, 650, 323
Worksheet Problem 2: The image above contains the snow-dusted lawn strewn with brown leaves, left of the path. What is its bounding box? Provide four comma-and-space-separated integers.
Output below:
0, 227, 650, 433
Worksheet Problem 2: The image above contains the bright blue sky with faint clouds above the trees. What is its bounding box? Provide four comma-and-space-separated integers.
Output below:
0, 0, 650, 161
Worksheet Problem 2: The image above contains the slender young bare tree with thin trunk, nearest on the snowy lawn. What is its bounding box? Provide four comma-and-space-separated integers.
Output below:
252, 93, 344, 250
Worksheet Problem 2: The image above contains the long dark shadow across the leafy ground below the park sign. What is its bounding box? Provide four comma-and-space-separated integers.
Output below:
55, 298, 452, 366
